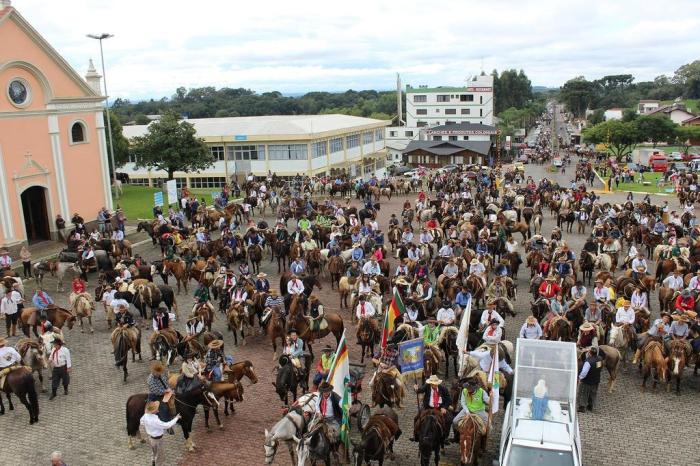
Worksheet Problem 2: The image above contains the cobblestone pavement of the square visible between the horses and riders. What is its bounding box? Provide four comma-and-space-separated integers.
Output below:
0, 157, 700, 466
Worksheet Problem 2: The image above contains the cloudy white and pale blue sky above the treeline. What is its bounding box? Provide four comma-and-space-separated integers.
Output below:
13, 0, 700, 99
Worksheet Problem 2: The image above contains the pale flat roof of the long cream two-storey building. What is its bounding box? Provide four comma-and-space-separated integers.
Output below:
124, 114, 391, 138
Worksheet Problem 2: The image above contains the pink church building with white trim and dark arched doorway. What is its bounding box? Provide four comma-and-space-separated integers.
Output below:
0, 0, 112, 247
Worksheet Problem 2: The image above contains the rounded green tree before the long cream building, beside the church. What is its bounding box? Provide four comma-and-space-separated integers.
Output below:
133, 112, 215, 180
